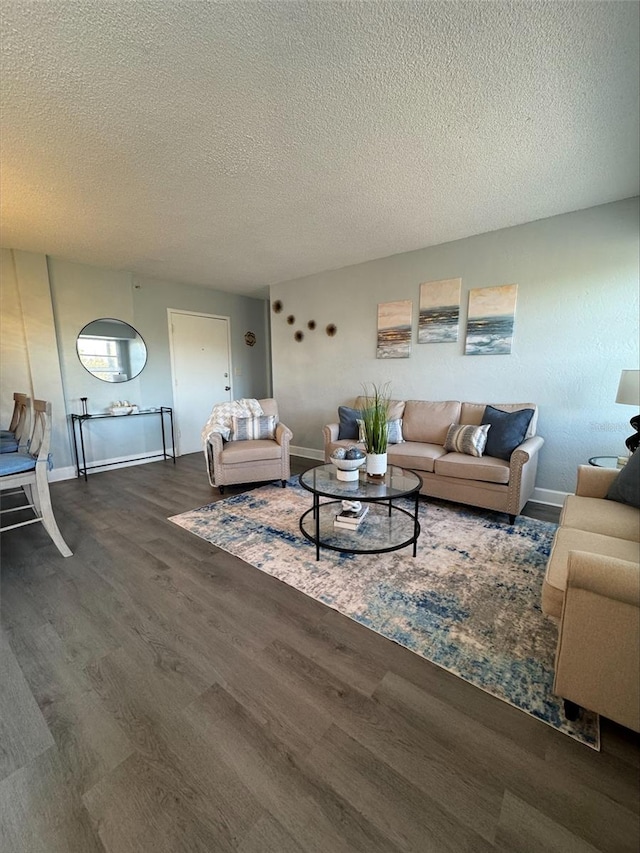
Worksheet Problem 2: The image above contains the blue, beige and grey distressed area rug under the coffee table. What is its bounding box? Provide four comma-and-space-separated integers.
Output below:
170, 478, 600, 749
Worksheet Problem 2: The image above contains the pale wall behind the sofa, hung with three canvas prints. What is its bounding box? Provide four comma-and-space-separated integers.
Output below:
271, 198, 639, 492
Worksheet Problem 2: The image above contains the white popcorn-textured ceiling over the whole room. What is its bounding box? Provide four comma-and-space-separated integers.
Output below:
0, 0, 640, 295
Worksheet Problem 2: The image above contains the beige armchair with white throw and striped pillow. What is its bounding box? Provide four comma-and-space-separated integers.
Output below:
205, 397, 293, 494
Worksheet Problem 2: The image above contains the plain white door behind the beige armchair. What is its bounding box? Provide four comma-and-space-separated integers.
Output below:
169, 311, 233, 456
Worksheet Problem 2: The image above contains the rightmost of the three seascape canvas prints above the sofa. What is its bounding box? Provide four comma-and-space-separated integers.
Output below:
465, 284, 518, 355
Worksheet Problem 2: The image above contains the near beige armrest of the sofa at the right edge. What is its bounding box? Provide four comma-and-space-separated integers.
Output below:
554, 551, 640, 731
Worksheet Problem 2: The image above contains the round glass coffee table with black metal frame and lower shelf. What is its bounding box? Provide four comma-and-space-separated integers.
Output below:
300, 464, 422, 560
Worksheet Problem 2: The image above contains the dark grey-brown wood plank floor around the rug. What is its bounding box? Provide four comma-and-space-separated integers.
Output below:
0, 454, 640, 853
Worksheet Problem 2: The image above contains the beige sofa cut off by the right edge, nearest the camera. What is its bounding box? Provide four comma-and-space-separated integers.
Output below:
542, 465, 640, 731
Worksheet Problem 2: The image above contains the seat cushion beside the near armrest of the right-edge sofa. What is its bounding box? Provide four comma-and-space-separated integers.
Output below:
542, 527, 640, 618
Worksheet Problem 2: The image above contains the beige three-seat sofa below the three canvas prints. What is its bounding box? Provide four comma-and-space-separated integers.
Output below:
323, 397, 544, 523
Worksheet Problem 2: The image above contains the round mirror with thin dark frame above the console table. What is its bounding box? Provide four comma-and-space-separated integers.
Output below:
76, 317, 147, 382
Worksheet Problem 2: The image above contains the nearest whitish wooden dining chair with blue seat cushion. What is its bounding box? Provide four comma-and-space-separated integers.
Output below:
0, 400, 71, 557
